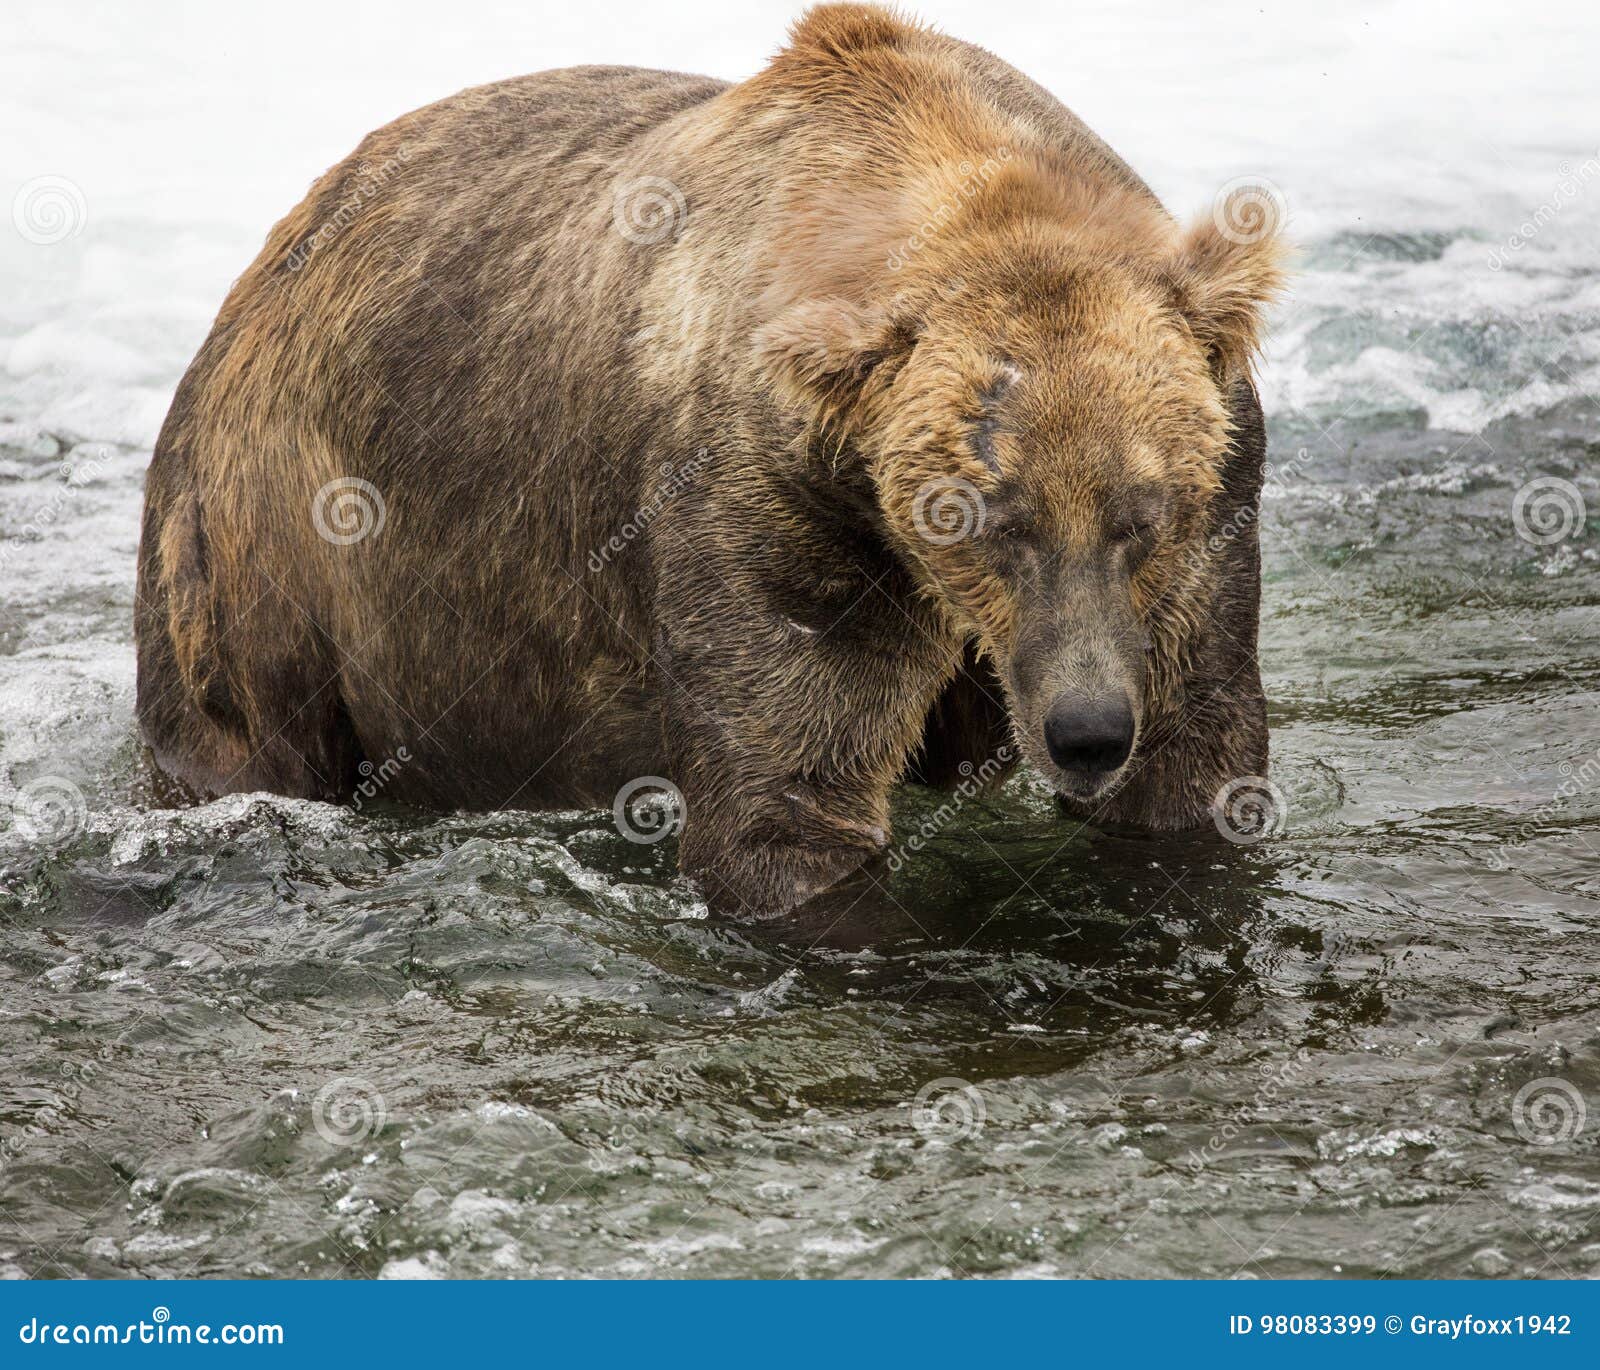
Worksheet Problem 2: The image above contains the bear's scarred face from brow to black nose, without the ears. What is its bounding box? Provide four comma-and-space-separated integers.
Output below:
869, 282, 1227, 800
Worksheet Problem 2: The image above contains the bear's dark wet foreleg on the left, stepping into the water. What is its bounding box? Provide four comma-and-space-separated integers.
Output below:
653, 508, 962, 915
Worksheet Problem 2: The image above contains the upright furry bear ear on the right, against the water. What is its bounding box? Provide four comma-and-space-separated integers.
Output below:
1168, 187, 1290, 378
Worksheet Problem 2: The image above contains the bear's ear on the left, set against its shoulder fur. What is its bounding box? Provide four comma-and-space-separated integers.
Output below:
754, 296, 917, 429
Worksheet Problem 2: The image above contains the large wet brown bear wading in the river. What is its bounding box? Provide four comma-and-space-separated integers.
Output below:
136, 5, 1280, 911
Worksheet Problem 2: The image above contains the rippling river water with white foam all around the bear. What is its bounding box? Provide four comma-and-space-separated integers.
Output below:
0, 3, 1600, 1277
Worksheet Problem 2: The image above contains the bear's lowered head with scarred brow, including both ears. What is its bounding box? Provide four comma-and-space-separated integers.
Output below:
758, 181, 1282, 802
